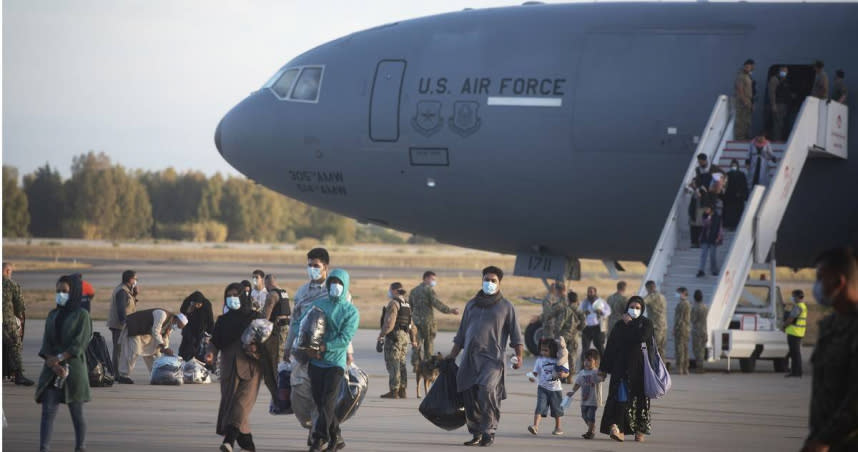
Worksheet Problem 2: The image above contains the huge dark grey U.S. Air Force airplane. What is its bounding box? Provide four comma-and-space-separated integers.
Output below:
215, 2, 858, 276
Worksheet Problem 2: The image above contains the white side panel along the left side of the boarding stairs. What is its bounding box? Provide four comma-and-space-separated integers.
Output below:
638, 94, 732, 296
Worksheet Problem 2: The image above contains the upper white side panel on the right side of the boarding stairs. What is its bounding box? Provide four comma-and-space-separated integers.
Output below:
754, 97, 821, 263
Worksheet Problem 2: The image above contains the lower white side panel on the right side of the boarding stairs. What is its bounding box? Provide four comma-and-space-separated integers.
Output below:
706, 185, 766, 340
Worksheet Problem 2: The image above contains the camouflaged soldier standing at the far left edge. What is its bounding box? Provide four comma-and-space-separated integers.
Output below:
3, 262, 33, 386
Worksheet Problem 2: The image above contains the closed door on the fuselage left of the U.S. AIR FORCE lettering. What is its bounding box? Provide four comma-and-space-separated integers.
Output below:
369, 60, 405, 142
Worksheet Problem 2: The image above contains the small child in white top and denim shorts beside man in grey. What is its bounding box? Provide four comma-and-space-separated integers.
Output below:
527, 339, 569, 435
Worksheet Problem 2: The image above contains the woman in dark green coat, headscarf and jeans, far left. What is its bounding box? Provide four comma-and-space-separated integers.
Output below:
36, 275, 92, 452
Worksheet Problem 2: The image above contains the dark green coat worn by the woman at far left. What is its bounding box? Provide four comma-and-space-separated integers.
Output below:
36, 308, 92, 403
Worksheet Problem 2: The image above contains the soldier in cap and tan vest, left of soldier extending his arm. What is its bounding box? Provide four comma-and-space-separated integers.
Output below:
378, 282, 417, 399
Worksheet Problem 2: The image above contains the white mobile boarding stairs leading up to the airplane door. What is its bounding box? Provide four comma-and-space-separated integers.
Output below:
639, 95, 848, 370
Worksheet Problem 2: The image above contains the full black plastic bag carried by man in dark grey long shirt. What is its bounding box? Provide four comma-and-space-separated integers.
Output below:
420, 360, 465, 430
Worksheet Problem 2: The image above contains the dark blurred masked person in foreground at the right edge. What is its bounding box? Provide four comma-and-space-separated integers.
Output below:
802, 247, 858, 452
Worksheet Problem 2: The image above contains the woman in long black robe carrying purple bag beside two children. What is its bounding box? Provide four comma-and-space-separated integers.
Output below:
599, 296, 655, 442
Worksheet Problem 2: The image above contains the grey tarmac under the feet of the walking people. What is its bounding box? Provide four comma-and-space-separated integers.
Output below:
2, 320, 811, 452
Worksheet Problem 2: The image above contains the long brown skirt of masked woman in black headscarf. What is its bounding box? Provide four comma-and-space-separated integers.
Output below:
216, 340, 262, 435
